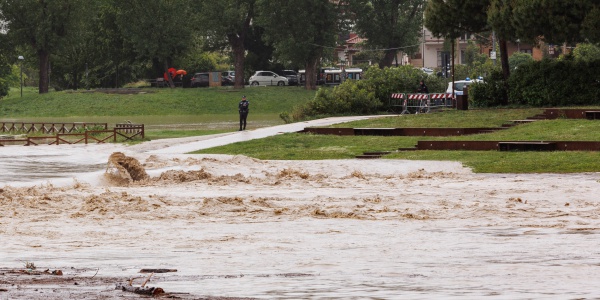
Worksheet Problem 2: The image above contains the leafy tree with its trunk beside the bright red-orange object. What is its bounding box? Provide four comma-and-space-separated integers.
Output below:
115, 0, 197, 87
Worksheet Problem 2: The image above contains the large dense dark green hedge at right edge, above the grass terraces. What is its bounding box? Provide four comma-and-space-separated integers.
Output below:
509, 60, 600, 106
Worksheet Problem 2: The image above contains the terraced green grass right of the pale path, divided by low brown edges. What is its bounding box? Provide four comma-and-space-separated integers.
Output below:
196, 109, 600, 173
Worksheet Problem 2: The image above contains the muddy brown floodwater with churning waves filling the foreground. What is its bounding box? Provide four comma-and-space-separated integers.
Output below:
0, 118, 600, 299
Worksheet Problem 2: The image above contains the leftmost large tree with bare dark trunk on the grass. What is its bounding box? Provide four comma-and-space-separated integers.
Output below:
0, 0, 86, 93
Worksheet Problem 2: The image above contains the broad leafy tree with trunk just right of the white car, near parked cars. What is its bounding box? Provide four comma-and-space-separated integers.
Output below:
258, 0, 340, 90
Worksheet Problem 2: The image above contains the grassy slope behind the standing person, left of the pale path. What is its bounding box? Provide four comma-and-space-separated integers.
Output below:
0, 87, 314, 118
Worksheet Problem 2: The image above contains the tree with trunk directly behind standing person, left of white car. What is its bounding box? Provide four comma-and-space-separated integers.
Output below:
198, 0, 256, 89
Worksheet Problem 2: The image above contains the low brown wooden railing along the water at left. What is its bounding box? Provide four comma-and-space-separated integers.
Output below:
0, 123, 145, 146
